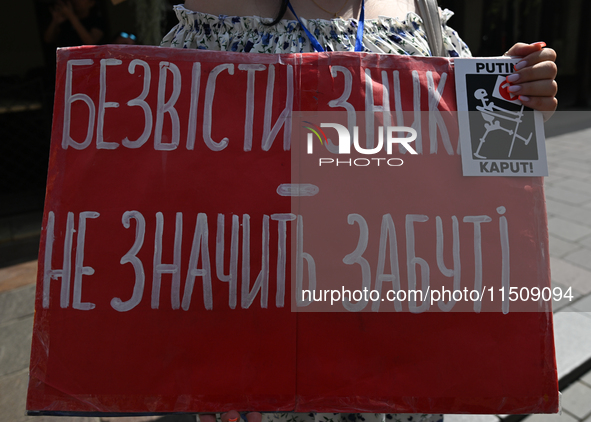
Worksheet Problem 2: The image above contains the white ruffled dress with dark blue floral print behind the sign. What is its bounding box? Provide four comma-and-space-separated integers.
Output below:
160, 5, 464, 422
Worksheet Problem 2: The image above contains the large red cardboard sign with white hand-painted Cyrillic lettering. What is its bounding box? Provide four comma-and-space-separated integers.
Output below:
27, 46, 558, 414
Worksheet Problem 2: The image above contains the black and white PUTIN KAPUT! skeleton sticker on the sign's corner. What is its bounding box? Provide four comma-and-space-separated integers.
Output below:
454, 57, 548, 177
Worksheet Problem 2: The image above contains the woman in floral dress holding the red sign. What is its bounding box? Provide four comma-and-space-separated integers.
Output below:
161, 0, 557, 422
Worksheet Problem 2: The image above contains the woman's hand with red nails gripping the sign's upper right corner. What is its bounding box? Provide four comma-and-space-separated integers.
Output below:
505, 42, 558, 121
